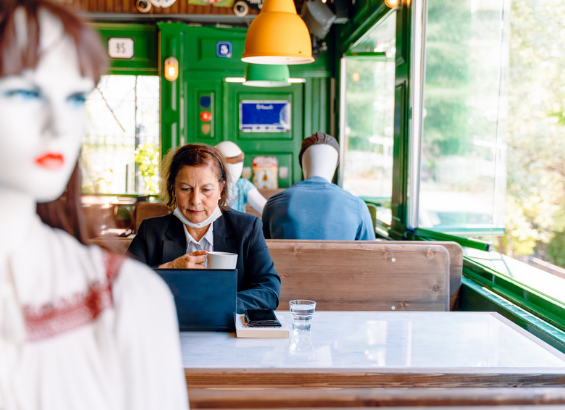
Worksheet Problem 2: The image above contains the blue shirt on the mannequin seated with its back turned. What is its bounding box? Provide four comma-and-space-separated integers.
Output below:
263, 177, 375, 241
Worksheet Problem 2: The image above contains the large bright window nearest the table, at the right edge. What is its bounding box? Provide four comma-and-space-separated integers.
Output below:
418, 0, 565, 276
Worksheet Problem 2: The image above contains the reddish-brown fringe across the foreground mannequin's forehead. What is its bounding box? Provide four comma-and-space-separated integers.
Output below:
0, 0, 108, 83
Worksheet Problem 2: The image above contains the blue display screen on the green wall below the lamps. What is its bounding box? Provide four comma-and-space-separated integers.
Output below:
239, 100, 290, 132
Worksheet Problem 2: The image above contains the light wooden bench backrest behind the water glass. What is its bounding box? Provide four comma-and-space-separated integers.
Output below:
268, 241, 449, 311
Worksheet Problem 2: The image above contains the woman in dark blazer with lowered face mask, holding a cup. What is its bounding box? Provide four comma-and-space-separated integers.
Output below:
128, 144, 281, 313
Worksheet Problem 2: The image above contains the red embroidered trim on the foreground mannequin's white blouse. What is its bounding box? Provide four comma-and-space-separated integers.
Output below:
23, 253, 125, 342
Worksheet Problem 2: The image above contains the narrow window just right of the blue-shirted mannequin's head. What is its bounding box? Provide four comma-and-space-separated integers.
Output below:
340, 13, 396, 224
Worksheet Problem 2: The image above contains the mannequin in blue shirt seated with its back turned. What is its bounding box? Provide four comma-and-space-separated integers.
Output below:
263, 132, 375, 241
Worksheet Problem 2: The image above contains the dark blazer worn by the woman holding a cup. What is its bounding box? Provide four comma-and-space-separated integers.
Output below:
128, 209, 281, 313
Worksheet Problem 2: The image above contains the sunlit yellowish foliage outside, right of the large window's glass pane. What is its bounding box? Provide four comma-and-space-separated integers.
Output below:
499, 0, 565, 267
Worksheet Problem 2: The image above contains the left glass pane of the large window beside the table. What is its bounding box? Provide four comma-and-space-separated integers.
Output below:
418, 0, 509, 234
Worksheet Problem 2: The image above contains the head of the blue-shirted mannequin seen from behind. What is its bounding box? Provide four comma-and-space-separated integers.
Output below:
298, 132, 339, 182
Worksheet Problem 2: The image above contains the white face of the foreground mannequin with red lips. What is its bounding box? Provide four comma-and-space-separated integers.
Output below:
0, 13, 94, 201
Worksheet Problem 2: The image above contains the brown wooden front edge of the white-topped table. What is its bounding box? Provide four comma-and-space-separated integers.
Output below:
184, 368, 565, 389
